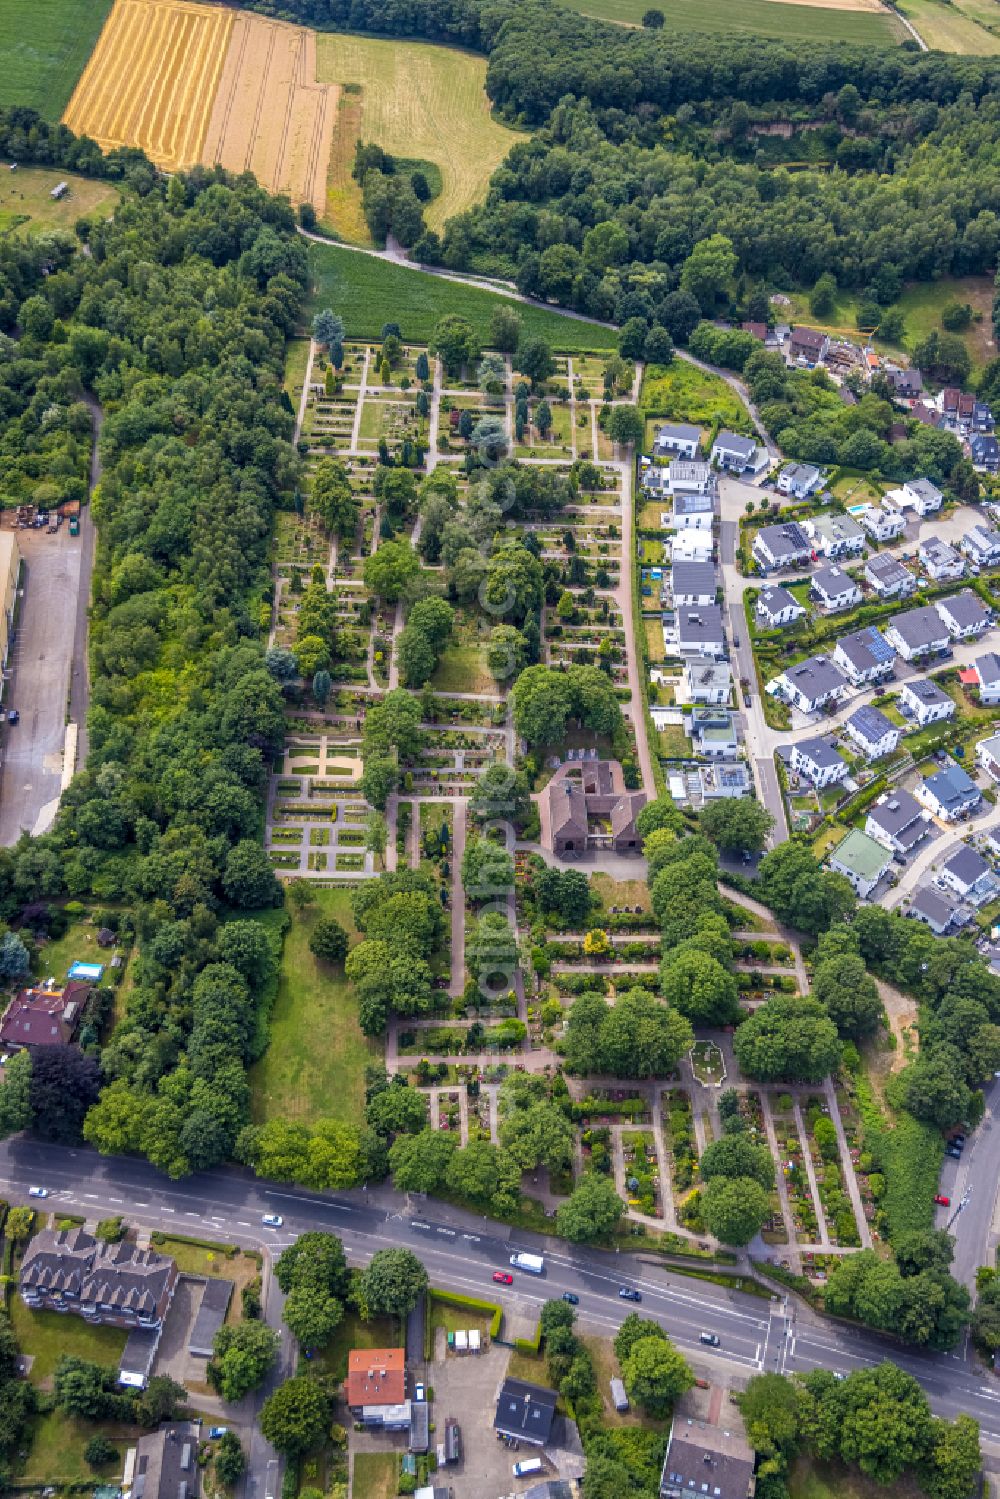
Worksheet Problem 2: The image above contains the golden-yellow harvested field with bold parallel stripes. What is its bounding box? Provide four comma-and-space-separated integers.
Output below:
63, 0, 234, 169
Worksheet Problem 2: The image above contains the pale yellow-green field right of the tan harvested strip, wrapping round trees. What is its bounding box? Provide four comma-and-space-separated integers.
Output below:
316, 33, 523, 243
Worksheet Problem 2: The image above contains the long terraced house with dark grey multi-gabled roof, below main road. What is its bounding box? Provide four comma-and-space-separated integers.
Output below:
18, 1228, 177, 1328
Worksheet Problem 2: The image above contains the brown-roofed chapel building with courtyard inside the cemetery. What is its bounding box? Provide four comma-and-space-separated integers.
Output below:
538, 760, 646, 859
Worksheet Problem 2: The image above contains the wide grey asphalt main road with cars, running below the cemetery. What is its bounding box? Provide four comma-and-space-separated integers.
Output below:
0, 1136, 1000, 1451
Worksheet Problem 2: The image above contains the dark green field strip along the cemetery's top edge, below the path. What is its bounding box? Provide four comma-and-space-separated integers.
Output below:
307, 244, 618, 354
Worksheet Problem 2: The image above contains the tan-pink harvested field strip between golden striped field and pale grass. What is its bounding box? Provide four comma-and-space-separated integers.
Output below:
201, 10, 339, 210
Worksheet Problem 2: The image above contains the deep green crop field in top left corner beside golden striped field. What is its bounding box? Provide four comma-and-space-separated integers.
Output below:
0, 0, 111, 120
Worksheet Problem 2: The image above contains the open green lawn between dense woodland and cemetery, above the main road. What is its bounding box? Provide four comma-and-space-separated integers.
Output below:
250, 887, 379, 1124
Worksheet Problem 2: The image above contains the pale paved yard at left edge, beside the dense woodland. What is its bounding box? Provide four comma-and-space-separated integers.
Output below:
0, 526, 85, 845
